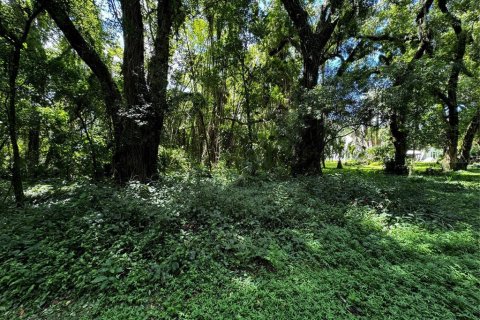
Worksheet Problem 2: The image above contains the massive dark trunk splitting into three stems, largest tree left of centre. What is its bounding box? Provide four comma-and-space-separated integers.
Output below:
40, 0, 174, 183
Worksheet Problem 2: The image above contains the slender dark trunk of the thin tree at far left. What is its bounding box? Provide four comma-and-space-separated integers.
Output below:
7, 43, 25, 206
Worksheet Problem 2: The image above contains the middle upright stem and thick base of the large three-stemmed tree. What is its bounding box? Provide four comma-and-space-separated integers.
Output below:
113, 0, 160, 183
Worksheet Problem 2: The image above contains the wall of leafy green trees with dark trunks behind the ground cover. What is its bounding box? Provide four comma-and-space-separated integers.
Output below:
0, 0, 480, 203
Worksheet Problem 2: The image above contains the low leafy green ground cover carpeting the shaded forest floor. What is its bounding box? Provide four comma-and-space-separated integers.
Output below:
0, 163, 480, 320
